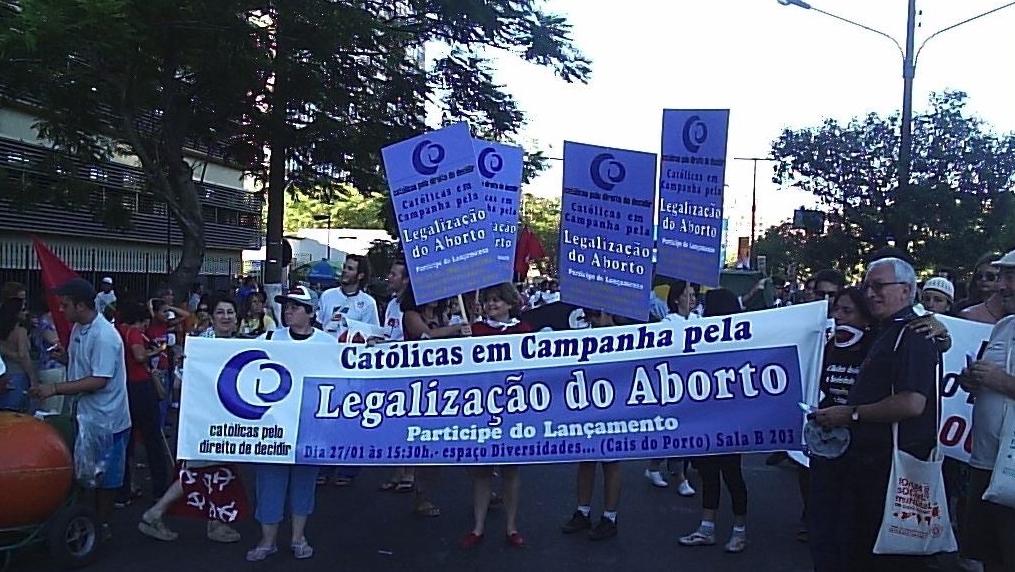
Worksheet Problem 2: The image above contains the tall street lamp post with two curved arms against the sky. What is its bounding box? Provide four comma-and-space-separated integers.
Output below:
779, 0, 1015, 243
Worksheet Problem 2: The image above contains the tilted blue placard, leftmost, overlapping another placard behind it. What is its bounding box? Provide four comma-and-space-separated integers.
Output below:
381, 123, 497, 303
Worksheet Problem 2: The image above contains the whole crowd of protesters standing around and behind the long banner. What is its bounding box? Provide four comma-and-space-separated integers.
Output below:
0, 246, 1015, 572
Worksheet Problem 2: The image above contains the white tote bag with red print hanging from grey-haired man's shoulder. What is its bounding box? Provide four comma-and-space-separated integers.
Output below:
874, 423, 958, 556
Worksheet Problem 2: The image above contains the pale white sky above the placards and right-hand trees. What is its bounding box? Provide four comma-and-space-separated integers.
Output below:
487, 0, 1015, 254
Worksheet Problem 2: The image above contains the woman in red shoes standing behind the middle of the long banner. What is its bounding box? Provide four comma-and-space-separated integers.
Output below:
461, 282, 532, 549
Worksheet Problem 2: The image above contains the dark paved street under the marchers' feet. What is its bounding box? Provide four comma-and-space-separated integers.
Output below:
11, 454, 809, 572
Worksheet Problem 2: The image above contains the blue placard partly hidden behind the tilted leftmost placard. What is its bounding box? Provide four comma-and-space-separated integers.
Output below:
473, 139, 525, 282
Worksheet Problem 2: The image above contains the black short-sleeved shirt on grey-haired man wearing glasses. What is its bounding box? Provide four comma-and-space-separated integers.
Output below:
848, 307, 941, 456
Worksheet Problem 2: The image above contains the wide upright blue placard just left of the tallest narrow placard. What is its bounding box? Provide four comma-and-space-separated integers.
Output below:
559, 141, 656, 319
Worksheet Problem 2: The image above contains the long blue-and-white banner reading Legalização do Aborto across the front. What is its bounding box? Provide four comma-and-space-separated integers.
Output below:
179, 304, 825, 464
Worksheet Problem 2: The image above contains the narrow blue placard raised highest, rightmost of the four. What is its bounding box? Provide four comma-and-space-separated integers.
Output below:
657, 110, 730, 287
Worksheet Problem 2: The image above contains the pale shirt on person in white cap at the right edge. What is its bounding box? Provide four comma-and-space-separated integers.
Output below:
969, 315, 1015, 471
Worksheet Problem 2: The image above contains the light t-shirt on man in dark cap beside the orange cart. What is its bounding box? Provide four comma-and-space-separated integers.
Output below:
67, 314, 131, 433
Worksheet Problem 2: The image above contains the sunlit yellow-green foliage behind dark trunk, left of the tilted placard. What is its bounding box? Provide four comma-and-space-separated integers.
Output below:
285, 187, 385, 232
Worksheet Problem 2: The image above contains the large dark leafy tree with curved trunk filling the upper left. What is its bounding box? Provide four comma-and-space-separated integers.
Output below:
0, 0, 590, 294
